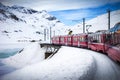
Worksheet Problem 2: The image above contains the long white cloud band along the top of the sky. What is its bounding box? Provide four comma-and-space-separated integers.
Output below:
0, 0, 119, 11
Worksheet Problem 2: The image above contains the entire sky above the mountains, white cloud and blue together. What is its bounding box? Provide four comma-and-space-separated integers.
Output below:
0, 0, 120, 25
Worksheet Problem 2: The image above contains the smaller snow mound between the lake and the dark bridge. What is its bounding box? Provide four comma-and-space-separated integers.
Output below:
1, 43, 45, 68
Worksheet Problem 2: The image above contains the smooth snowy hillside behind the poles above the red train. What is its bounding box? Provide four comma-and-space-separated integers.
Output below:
71, 10, 120, 34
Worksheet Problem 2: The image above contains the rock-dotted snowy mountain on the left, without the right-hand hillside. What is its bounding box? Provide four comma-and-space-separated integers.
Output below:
0, 3, 65, 43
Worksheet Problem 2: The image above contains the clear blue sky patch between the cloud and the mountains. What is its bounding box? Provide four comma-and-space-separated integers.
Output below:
49, 2, 120, 26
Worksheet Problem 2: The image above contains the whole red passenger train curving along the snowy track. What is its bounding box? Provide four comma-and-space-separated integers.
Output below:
52, 32, 120, 62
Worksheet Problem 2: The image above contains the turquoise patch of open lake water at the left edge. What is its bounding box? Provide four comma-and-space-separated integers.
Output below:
0, 48, 21, 59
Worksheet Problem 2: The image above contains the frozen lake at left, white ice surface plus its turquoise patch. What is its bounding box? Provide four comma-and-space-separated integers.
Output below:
0, 43, 28, 59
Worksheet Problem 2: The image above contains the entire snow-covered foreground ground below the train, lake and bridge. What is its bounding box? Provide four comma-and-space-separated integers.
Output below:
0, 43, 120, 80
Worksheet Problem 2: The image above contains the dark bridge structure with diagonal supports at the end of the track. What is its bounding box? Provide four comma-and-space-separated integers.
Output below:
40, 43, 61, 59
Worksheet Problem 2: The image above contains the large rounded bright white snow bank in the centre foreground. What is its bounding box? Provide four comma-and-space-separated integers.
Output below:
1, 47, 95, 80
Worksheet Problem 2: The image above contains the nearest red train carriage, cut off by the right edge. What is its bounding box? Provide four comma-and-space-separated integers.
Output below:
105, 33, 120, 62
